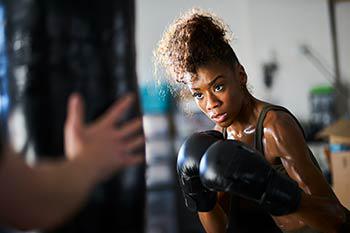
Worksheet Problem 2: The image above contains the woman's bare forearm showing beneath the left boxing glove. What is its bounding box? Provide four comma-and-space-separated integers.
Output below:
198, 203, 228, 233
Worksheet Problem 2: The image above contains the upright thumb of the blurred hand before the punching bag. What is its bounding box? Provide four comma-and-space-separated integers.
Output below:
66, 93, 84, 131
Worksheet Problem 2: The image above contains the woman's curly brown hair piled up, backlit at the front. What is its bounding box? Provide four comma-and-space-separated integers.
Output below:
154, 8, 239, 83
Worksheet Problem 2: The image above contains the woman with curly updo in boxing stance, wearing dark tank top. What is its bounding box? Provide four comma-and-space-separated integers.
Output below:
155, 10, 349, 232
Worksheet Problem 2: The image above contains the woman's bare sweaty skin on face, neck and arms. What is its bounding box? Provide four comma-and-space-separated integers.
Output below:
187, 63, 346, 233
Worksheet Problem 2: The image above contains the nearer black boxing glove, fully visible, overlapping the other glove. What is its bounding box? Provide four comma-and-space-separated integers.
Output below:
200, 140, 301, 216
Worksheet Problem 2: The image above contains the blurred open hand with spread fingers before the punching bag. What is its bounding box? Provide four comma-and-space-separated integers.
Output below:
65, 94, 145, 178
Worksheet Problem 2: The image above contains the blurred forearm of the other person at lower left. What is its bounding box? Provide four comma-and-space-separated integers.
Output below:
0, 156, 98, 229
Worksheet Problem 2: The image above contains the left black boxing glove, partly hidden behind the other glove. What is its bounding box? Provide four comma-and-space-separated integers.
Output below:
177, 130, 223, 212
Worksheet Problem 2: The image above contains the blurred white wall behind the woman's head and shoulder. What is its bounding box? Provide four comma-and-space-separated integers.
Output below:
136, 0, 350, 120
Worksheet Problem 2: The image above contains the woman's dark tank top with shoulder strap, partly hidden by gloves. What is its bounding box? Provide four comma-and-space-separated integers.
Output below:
224, 105, 320, 233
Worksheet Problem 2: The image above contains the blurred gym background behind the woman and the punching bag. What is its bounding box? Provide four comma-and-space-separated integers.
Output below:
0, 0, 350, 233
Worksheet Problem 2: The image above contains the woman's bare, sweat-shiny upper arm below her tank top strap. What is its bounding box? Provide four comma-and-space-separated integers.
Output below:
264, 111, 334, 196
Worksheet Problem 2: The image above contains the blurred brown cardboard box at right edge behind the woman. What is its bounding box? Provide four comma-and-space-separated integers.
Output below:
318, 120, 350, 209
